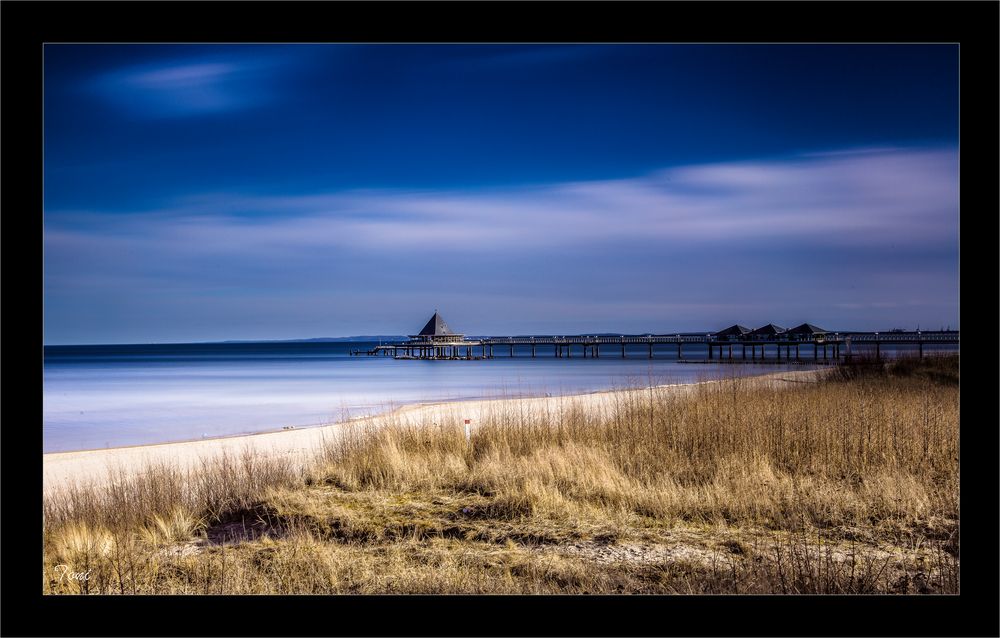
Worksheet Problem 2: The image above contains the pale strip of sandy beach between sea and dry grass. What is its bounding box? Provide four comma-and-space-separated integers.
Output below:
42, 370, 827, 492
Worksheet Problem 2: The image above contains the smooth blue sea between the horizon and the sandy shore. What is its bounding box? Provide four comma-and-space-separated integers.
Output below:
43, 342, 952, 452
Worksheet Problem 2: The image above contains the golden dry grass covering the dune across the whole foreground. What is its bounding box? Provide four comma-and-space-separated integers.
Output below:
43, 356, 959, 593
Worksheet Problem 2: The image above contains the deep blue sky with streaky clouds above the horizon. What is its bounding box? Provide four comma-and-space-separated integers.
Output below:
44, 44, 959, 344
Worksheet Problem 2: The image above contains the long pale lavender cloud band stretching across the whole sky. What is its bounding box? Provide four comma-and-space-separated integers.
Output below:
47, 150, 958, 255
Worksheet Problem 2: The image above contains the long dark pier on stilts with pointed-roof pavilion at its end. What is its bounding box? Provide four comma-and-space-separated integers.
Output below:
356, 312, 959, 363
